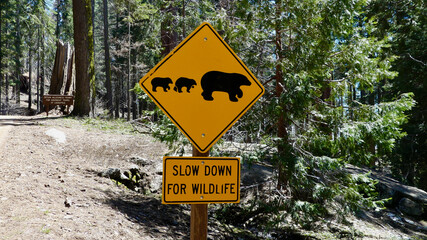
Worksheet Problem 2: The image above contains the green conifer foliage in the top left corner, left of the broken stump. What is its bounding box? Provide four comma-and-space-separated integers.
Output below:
0, 0, 55, 109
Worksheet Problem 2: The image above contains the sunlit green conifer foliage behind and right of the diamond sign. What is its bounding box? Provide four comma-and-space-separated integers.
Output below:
132, 0, 415, 231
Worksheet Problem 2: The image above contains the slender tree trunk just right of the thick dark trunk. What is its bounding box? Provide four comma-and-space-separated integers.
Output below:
103, 0, 113, 115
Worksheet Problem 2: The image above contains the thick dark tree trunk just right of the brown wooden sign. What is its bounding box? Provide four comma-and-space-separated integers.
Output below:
72, 0, 95, 116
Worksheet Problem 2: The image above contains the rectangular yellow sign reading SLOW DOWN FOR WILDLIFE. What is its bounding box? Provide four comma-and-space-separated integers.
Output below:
162, 157, 240, 204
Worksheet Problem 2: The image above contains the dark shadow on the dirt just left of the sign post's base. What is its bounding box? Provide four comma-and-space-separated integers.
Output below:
105, 192, 190, 239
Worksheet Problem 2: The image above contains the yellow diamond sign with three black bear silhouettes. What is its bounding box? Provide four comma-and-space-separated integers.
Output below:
139, 23, 265, 152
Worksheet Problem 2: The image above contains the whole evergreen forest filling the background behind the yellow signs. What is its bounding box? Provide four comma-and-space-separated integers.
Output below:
0, 0, 427, 232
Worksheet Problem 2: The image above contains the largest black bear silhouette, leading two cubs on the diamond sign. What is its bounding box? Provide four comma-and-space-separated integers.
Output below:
200, 71, 251, 102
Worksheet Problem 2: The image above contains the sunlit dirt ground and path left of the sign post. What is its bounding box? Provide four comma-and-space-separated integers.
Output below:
0, 115, 189, 240
